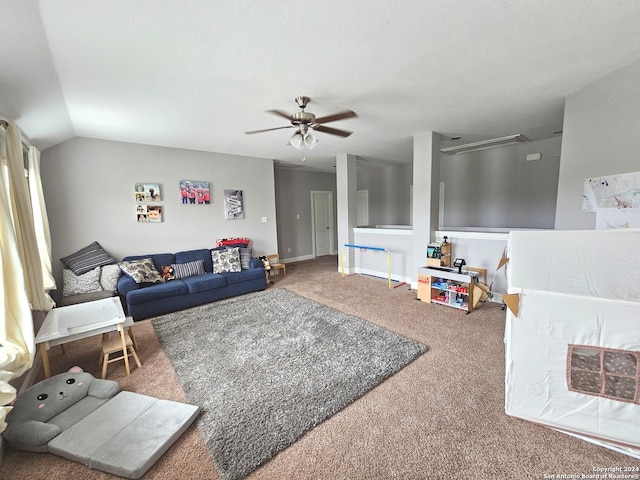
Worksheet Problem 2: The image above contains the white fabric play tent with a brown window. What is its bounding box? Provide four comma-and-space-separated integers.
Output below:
505, 229, 640, 458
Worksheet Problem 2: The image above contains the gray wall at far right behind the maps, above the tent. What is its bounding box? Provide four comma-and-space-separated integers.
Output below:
556, 58, 640, 230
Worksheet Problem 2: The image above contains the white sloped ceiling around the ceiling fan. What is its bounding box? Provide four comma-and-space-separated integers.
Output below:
0, 0, 640, 170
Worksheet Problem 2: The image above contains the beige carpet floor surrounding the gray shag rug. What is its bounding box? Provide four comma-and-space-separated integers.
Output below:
0, 256, 640, 480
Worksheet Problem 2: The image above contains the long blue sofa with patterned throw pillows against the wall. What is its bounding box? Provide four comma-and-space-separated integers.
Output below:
118, 248, 266, 320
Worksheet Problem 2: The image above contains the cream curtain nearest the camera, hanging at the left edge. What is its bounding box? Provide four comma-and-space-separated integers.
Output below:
0, 122, 54, 431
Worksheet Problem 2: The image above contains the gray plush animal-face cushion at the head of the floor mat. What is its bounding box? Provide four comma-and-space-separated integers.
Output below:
2, 367, 120, 452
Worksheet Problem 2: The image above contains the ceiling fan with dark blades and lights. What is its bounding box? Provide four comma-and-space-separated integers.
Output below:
244, 96, 358, 150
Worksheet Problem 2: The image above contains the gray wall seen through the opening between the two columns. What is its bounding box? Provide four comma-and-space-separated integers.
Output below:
357, 162, 413, 226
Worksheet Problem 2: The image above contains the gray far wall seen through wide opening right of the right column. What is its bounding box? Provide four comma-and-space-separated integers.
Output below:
440, 136, 562, 228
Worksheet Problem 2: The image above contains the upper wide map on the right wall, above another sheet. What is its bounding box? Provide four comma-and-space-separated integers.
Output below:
582, 172, 640, 212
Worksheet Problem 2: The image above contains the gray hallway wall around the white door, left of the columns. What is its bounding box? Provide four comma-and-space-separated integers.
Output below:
274, 167, 338, 260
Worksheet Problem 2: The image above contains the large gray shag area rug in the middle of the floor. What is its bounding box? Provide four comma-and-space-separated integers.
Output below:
152, 288, 427, 480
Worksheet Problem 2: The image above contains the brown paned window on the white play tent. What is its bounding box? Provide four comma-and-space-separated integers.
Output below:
567, 345, 640, 404
